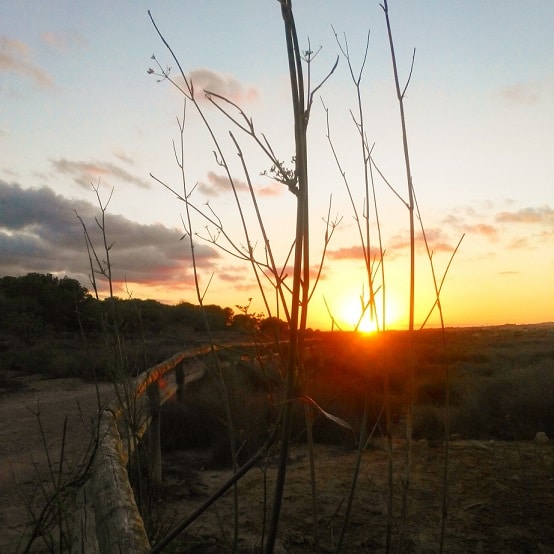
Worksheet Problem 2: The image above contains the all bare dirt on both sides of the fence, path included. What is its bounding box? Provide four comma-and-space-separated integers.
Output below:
0, 378, 554, 553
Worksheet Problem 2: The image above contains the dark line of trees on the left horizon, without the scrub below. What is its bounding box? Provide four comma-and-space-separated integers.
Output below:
0, 273, 286, 334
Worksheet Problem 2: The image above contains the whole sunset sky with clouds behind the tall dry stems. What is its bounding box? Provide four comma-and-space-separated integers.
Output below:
0, 0, 554, 330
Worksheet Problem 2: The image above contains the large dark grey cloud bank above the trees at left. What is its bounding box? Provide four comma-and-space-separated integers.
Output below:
0, 180, 219, 294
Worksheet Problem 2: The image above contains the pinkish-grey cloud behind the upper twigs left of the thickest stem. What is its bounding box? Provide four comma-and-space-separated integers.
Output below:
177, 69, 260, 104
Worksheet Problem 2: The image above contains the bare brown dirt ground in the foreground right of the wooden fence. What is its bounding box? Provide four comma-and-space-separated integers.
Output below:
155, 441, 554, 553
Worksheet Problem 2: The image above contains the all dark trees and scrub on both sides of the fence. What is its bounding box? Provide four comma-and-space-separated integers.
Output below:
0, 273, 554, 446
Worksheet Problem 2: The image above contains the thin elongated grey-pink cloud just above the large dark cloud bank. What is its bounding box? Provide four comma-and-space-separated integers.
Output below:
50, 158, 151, 189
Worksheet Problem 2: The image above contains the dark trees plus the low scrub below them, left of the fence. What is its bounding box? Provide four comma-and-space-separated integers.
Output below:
0, 273, 288, 380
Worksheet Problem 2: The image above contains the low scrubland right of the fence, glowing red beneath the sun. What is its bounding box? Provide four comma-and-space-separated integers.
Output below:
162, 325, 554, 465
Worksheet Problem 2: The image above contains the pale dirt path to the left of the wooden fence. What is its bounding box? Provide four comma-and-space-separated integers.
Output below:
0, 376, 112, 553
